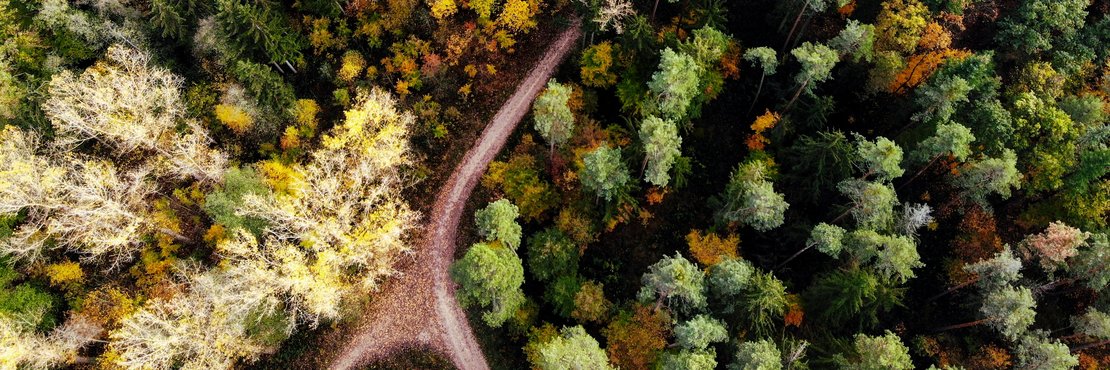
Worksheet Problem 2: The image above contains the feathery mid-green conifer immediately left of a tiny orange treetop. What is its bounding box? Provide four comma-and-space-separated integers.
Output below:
738, 271, 788, 336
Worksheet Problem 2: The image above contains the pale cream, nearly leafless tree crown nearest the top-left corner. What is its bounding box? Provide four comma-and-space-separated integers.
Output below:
42, 46, 226, 182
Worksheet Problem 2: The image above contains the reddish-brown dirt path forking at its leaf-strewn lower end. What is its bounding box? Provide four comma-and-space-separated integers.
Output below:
329, 21, 581, 370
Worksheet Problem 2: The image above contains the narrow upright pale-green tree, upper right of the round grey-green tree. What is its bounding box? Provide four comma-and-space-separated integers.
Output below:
639, 116, 683, 187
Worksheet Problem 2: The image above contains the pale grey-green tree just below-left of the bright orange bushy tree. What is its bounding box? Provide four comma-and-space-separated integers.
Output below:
636, 248, 706, 312
